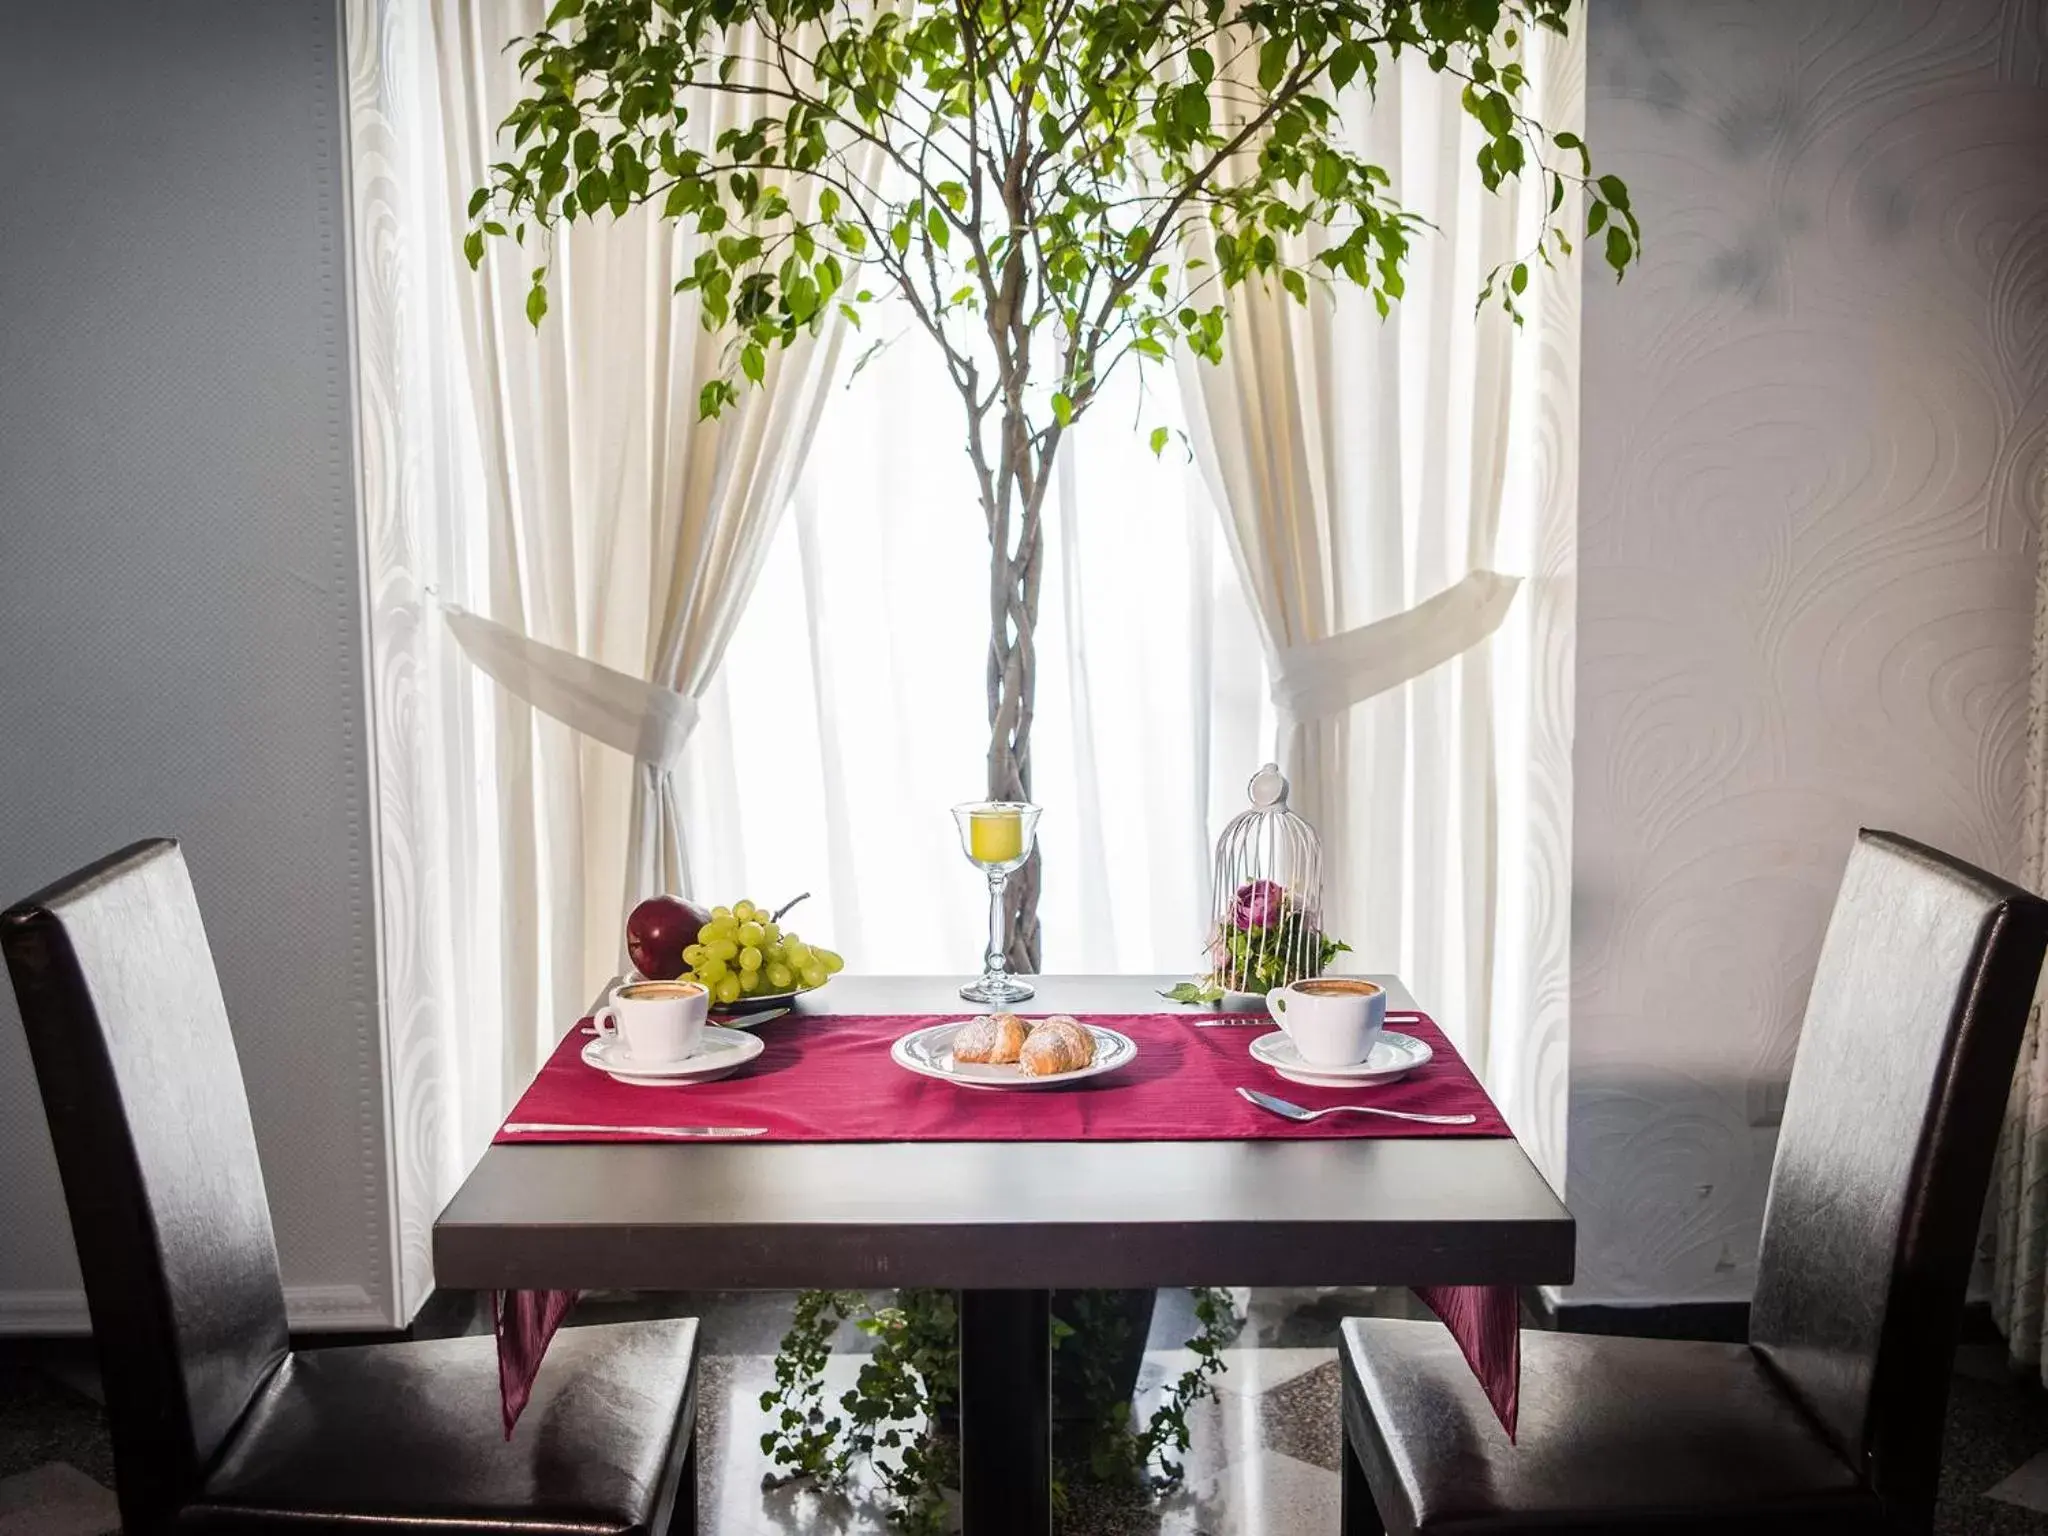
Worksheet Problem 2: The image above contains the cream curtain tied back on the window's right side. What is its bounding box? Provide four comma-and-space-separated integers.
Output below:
1180, 29, 1583, 1178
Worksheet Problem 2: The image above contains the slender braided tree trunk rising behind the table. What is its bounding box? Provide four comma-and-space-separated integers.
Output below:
983, 412, 1057, 975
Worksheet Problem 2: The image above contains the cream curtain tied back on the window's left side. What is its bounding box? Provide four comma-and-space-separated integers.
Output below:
346, 0, 876, 1292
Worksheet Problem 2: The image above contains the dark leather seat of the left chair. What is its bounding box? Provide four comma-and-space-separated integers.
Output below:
178, 1319, 696, 1536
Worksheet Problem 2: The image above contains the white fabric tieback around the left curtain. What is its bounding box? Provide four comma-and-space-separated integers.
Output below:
440, 602, 696, 772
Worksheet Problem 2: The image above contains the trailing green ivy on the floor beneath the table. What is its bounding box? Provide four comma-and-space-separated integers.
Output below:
760, 1286, 1239, 1536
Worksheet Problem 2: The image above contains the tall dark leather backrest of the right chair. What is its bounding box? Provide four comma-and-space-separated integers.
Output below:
1749, 831, 2048, 1524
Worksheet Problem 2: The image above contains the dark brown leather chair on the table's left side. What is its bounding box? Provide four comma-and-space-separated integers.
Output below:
0, 842, 696, 1536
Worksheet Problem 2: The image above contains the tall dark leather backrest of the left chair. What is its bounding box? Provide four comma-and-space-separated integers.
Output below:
0, 842, 287, 1536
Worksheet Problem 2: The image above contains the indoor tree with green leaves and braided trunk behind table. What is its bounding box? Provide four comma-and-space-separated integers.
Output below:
465, 0, 1638, 971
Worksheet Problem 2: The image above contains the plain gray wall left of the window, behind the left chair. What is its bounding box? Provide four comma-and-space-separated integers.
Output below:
0, 0, 391, 1331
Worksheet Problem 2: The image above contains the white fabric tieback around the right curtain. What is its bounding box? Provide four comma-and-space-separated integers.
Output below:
1274, 571, 1522, 721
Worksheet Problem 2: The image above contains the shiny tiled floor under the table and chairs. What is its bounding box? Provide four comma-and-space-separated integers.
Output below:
12, 1290, 2048, 1536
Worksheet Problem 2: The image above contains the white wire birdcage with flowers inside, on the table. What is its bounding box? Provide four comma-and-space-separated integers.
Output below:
1208, 762, 1331, 997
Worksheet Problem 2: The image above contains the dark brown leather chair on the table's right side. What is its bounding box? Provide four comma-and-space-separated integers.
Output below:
1341, 831, 2048, 1536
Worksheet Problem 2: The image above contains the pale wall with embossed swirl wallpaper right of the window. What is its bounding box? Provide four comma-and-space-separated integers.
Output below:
1567, 0, 2048, 1303
